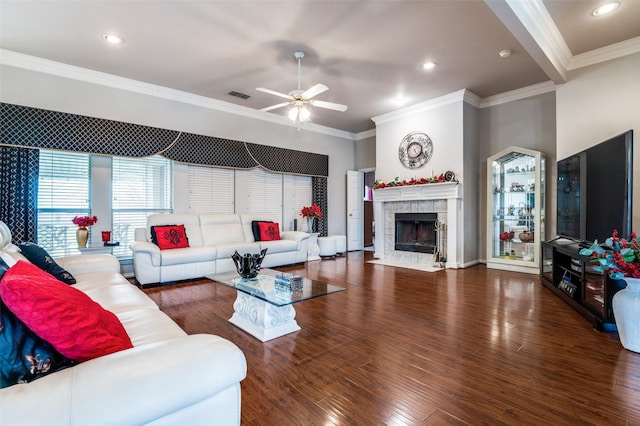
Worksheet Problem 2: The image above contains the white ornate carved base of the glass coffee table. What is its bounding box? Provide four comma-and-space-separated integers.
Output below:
229, 291, 300, 342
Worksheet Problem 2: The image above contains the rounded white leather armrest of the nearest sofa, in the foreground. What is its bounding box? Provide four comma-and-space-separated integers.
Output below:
0, 334, 247, 425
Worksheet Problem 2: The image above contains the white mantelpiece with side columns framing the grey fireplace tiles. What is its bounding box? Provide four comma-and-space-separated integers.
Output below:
373, 182, 463, 268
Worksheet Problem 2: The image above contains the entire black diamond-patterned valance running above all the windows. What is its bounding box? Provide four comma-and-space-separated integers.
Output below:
0, 102, 329, 176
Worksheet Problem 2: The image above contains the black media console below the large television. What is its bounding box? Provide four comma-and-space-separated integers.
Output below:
540, 237, 625, 331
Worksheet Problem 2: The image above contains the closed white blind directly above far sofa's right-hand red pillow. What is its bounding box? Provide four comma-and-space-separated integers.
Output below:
248, 169, 282, 226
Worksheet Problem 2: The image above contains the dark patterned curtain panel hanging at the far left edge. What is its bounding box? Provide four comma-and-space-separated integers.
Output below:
0, 146, 40, 242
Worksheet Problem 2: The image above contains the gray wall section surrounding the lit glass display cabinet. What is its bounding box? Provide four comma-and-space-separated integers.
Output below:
478, 92, 556, 259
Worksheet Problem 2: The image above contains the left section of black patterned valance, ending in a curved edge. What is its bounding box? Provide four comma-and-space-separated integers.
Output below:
0, 102, 179, 157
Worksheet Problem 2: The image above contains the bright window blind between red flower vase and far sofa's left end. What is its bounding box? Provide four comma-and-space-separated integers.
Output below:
111, 156, 173, 256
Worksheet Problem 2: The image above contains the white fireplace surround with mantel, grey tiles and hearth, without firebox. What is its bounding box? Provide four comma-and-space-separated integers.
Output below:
374, 182, 462, 268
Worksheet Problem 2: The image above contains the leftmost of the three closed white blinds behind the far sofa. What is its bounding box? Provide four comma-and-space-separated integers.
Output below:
187, 166, 235, 213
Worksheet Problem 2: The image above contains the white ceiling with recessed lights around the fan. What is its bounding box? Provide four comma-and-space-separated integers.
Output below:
0, 0, 640, 133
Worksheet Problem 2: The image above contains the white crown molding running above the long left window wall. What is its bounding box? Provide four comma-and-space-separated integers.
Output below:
0, 49, 356, 141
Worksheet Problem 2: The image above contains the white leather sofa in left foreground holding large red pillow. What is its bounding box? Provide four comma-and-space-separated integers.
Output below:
0, 222, 246, 425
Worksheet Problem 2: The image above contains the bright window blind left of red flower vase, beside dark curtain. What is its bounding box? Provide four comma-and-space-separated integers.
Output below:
37, 150, 91, 256
